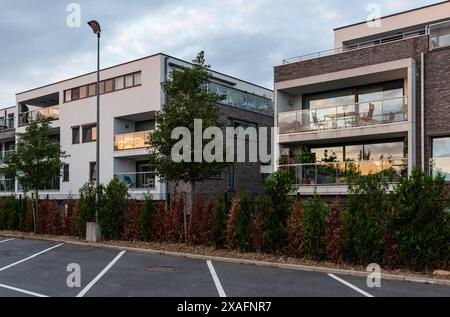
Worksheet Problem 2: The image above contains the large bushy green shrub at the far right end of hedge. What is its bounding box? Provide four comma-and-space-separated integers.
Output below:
392, 169, 450, 270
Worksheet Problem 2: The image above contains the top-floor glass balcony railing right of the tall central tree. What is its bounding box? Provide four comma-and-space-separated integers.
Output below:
208, 82, 273, 115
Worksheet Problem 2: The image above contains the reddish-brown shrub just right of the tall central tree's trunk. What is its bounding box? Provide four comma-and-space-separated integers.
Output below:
188, 196, 215, 245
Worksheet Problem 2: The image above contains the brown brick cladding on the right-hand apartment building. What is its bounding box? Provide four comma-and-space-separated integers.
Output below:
275, 35, 450, 168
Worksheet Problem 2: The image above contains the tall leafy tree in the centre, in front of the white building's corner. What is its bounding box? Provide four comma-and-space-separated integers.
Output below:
149, 52, 226, 205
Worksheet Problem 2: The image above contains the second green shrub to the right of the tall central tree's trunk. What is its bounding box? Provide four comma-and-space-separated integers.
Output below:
227, 192, 254, 251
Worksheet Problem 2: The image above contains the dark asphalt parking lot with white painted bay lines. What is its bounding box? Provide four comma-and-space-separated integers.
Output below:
0, 237, 450, 297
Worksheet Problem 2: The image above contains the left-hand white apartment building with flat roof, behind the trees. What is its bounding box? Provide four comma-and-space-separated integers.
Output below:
0, 54, 273, 200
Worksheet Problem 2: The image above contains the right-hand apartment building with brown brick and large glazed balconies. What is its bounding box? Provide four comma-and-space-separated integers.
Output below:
275, 1, 450, 196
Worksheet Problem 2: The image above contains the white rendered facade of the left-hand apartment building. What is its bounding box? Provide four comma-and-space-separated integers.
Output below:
5, 54, 272, 200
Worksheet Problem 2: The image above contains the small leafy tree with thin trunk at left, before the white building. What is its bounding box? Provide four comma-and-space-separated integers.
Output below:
5, 118, 67, 233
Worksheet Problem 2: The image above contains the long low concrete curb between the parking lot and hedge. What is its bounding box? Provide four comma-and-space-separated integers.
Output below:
0, 233, 450, 286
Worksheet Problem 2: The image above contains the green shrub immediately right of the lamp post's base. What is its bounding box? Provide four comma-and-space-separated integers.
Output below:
98, 179, 129, 240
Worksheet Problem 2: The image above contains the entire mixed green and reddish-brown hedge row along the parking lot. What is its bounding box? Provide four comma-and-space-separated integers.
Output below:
0, 170, 450, 270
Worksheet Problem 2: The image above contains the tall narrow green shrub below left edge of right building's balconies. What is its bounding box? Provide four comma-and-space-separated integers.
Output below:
264, 170, 295, 252
